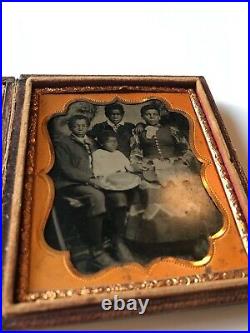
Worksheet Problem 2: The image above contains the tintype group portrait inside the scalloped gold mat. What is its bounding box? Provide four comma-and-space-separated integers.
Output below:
44, 98, 223, 274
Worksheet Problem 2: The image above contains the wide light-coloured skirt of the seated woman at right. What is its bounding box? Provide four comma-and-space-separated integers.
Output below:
125, 160, 223, 243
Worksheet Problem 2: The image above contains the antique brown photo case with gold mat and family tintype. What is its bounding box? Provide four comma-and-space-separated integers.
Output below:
2, 75, 247, 328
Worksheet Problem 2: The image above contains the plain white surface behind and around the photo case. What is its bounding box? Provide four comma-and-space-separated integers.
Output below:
3, 3, 248, 330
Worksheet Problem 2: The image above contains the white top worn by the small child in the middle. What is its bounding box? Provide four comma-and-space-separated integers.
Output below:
92, 149, 132, 177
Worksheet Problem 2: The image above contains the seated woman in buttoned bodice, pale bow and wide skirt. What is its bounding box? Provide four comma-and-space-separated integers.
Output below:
126, 102, 223, 260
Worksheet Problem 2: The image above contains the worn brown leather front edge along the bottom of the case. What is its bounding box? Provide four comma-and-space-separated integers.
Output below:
3, 286, 247, 330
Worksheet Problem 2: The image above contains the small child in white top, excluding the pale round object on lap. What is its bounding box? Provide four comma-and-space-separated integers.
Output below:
93, 131, 136, 262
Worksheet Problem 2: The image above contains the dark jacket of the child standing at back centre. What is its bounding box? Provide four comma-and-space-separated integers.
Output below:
88, 121, 135, 157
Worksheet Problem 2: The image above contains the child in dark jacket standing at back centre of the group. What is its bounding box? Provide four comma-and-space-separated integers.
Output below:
88, 103, 135, 157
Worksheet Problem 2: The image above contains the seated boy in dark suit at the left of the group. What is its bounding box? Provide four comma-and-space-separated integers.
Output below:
51, 115, 116, 270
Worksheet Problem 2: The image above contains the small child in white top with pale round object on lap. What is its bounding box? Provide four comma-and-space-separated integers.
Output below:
93, 131, 140, 262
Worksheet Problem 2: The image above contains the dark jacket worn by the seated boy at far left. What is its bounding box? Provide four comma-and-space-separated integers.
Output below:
50, 136, 96, 189
